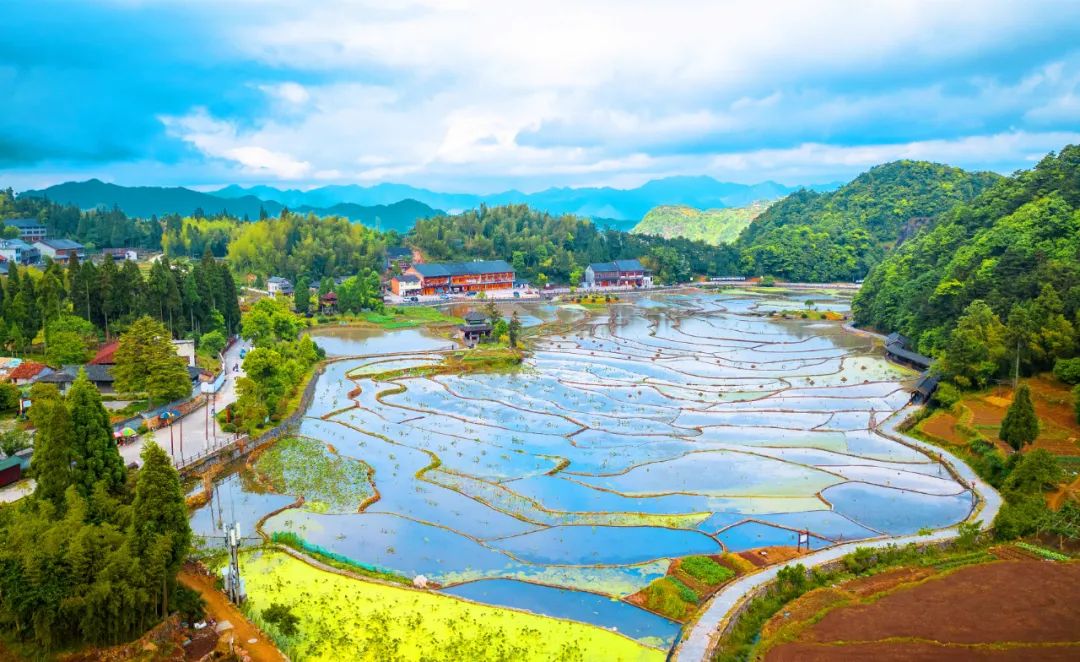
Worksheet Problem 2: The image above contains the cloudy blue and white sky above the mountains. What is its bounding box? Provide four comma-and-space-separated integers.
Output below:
0, 0, 1080, 193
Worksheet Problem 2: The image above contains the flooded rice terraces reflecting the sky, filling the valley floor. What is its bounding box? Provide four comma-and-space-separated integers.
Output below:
192, 292, 972, 648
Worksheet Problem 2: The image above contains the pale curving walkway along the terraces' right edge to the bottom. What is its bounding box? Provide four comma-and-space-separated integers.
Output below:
671, 369, 1001, 662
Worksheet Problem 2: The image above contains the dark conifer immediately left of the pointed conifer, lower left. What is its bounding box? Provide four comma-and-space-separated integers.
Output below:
30, 383, 75, 510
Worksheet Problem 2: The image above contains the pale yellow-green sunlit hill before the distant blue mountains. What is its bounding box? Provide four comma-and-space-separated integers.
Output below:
631, 201, 769, 245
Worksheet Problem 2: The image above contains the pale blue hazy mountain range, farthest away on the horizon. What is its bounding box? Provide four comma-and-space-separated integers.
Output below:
213, 176, 840, 222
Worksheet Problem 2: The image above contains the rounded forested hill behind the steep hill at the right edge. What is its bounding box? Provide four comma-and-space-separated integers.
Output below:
737, 161, 1000, 282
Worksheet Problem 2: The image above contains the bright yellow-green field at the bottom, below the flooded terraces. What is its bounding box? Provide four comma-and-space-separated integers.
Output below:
242, 551, 664, 662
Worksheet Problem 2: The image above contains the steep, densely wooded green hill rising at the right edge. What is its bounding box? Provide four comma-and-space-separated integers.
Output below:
853, 146, 1080, 370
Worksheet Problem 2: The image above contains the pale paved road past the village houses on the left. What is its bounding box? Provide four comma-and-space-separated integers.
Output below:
120, 341, 247, 464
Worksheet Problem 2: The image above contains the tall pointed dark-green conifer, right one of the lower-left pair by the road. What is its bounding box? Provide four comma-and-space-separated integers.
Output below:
67, 369, 126, 498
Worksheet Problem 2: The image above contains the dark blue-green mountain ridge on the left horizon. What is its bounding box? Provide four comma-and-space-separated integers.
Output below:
19, 179, 442, 232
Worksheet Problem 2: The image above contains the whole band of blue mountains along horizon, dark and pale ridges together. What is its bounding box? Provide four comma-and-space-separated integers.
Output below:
21, 177, 839, 232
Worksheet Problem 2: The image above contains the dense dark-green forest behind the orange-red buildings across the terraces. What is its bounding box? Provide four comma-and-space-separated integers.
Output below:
407, 205, 738, 285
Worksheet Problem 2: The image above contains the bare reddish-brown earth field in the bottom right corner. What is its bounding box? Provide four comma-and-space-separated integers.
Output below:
766, 560, 1080, 662
